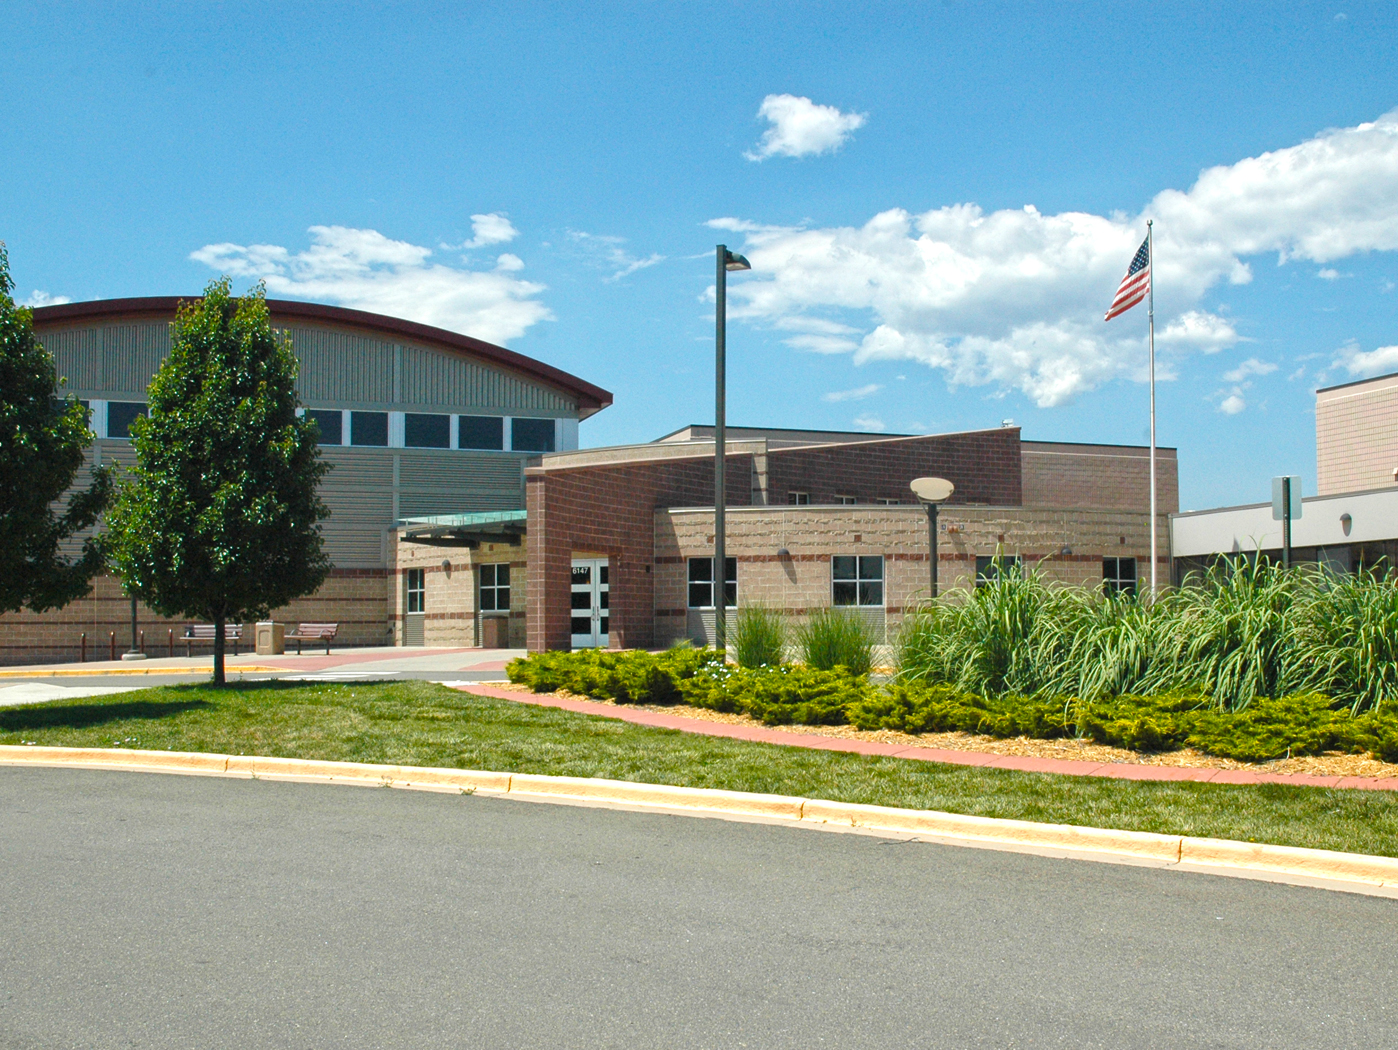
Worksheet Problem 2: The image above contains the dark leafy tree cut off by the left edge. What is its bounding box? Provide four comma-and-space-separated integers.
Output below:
0, 242, 110, 612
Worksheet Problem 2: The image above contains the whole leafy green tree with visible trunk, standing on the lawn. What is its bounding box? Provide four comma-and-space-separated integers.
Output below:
109, 277, 330, 685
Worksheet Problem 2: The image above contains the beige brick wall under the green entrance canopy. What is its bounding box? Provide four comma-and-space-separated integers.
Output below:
390, 534, 527, 649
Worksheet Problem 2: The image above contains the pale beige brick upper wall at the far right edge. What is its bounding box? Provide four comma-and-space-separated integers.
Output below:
1316, 376, 1398, 496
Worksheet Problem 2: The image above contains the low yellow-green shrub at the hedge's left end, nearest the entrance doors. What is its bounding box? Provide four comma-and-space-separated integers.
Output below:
505, 647, 719, 703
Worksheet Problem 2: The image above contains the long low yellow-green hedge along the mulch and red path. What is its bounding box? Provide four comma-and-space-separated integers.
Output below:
506, 649, 1398, 762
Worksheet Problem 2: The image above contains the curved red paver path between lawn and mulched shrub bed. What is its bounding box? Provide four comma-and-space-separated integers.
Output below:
457, 682, 1398, 791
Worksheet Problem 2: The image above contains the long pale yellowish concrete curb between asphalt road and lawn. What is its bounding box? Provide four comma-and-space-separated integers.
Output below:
0, 744, 1398, 889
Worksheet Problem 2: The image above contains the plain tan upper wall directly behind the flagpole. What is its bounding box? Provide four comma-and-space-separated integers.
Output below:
1019, 442, 1180, 515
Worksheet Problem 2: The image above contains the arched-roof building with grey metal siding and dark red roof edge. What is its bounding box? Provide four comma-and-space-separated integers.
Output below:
0, 298, 611, 663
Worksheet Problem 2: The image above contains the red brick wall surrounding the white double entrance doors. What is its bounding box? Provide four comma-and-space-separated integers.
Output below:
526, 454, 752, 652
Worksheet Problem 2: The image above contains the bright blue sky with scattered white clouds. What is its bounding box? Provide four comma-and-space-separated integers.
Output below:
0, 3, 1398, 508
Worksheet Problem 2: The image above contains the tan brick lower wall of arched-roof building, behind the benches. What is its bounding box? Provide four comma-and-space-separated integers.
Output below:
0, 569, 389, 664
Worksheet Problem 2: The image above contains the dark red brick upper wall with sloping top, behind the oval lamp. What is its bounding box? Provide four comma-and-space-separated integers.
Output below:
768, 426, 1023, 506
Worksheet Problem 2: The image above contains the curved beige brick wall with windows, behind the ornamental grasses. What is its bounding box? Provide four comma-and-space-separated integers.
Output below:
656, 506, 1169, 645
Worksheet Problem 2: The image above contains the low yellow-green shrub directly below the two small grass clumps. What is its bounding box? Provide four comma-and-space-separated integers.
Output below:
679, 664, 870, 726
